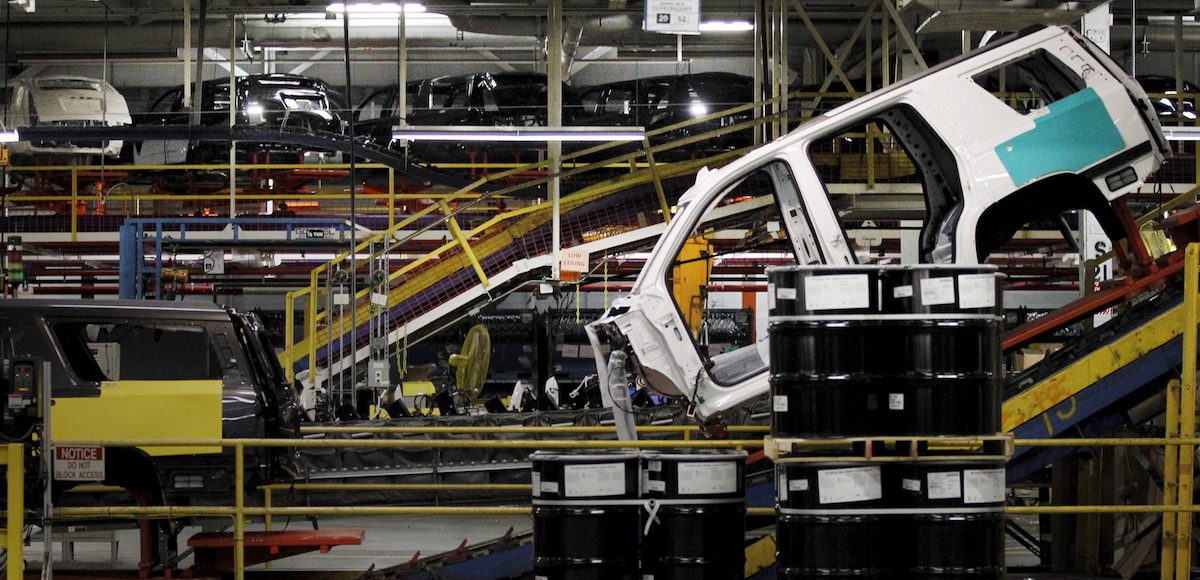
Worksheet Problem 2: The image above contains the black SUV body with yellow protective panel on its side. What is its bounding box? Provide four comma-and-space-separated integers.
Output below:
0, 299, 300, 506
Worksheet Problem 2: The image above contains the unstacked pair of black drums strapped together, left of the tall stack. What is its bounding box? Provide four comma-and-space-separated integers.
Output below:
530, 450, 746, 580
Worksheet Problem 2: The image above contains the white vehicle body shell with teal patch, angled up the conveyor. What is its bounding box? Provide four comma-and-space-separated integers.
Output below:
588, 28, 1169, 423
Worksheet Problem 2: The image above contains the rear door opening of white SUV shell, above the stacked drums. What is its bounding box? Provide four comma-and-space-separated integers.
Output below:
808, 104, 962, 263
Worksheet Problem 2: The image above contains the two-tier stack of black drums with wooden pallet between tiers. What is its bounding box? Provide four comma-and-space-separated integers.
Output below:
769, 265, 1007, 579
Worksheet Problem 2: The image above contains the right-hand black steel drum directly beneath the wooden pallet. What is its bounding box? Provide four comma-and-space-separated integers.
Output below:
892, 461, 1004, 580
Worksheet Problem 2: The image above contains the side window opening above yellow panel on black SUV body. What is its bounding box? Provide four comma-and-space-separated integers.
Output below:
52, 319, 222, 382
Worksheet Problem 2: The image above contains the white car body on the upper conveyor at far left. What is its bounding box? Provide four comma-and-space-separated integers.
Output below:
2, 76, 133, 156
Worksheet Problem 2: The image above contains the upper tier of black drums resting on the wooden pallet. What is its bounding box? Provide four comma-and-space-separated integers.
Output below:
769, 265, 1003, 438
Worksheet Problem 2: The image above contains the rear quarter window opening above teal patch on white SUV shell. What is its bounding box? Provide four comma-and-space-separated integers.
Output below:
972, 49, 1087, 114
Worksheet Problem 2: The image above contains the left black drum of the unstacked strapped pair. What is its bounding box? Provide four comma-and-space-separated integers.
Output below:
529, 450, 641, 580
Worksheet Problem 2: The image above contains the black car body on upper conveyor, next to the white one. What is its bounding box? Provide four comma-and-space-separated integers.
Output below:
131, 74, 346, 165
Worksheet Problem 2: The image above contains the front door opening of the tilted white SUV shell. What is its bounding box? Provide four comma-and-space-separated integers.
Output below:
666, 161, 822, 384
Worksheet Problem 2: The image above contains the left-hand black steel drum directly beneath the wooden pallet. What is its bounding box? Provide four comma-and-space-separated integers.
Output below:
775, 462, 898, 580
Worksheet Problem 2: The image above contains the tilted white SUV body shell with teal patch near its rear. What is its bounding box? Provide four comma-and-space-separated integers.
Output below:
588, 28, 1169, 419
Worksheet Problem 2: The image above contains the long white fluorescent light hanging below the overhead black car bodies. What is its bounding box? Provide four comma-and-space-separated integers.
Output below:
391, 126, 646, 143
